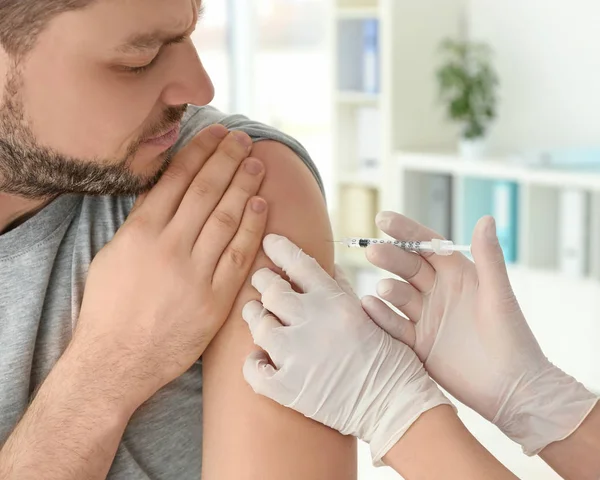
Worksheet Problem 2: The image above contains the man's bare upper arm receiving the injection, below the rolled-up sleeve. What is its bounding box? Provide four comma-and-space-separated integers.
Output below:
202, 141, 356, 480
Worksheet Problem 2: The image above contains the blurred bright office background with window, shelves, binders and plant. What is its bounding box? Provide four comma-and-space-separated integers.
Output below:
194, 0, 600, 480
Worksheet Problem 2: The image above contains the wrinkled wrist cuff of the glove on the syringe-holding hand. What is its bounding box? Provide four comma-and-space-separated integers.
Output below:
493, 364, 598, 456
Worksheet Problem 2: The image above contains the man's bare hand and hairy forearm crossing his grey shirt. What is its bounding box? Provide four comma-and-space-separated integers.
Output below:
0, 125, 267, 480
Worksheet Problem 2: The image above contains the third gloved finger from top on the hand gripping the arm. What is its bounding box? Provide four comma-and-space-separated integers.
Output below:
242, 300, 284, 368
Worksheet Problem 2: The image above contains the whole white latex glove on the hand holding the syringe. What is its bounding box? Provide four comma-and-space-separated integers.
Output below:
363, 212, 597, 455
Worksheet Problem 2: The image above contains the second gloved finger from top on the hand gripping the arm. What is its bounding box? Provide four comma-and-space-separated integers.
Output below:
252, 268, 305, 326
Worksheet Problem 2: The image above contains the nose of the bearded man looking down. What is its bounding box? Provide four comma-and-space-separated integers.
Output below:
162, 40, 215, 106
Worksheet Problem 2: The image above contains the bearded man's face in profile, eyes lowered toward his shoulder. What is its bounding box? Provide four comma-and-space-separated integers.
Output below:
0, 0, 214, 198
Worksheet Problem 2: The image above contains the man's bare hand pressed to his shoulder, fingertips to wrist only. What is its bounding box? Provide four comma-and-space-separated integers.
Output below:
70, 126, 267, 406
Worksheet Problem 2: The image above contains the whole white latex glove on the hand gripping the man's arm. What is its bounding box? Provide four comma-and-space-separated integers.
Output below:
242, 235, 450, 465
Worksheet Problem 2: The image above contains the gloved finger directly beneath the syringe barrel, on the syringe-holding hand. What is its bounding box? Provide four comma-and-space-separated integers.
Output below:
367, 244, 436, 293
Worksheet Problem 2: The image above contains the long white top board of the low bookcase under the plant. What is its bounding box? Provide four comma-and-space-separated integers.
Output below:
395, 152, 600, 191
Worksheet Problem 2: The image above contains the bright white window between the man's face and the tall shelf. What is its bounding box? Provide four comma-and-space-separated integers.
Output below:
193, 0, 332, 200
